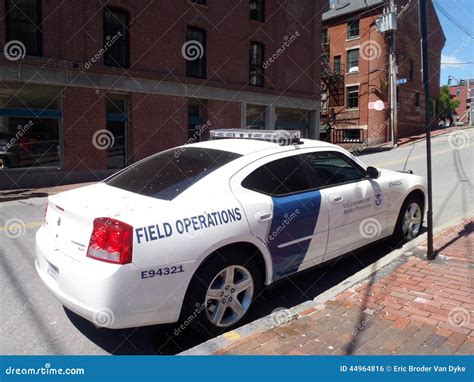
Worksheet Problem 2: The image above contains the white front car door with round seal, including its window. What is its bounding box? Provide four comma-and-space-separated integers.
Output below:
302, 151, 388, 261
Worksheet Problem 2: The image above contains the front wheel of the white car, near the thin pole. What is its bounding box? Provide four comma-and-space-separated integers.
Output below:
392, 196, 423, 246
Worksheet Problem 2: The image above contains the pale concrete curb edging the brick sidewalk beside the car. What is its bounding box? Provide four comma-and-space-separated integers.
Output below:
178, 215, 469, 355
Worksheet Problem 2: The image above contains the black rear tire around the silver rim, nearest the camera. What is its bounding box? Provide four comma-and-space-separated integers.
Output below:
178, 248, 262, 336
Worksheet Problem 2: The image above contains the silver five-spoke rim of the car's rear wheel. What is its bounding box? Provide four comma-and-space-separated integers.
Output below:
206, 265, 254, 328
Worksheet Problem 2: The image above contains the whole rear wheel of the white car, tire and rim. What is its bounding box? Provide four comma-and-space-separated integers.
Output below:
181, 250, 261, 335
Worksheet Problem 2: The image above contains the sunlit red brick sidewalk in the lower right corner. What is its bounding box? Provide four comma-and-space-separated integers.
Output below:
218, 220, 474, 355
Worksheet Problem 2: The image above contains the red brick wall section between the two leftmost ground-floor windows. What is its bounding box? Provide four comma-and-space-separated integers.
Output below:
62, 88, 107, 171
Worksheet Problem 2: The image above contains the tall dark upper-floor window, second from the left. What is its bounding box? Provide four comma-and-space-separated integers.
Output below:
103, 6, 130, 69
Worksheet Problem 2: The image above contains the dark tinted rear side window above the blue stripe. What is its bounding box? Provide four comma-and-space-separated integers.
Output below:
242, 155, 311, 196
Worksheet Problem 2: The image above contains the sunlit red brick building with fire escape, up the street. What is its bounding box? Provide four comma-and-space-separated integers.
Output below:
321, 0, 445, 147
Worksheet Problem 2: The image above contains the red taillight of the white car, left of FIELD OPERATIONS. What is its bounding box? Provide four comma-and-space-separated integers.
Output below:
87, 218, 133, 264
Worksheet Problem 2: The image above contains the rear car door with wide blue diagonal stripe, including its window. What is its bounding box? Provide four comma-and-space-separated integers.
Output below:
231, 153, 328, 280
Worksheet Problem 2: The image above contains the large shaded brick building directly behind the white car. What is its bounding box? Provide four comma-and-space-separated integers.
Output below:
0, 0, 327, 189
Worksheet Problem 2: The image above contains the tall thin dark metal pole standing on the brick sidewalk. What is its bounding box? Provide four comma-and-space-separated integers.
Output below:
418, 0, 435, 260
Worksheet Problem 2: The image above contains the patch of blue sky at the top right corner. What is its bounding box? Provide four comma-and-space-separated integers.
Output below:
433, 0, 474, 85
